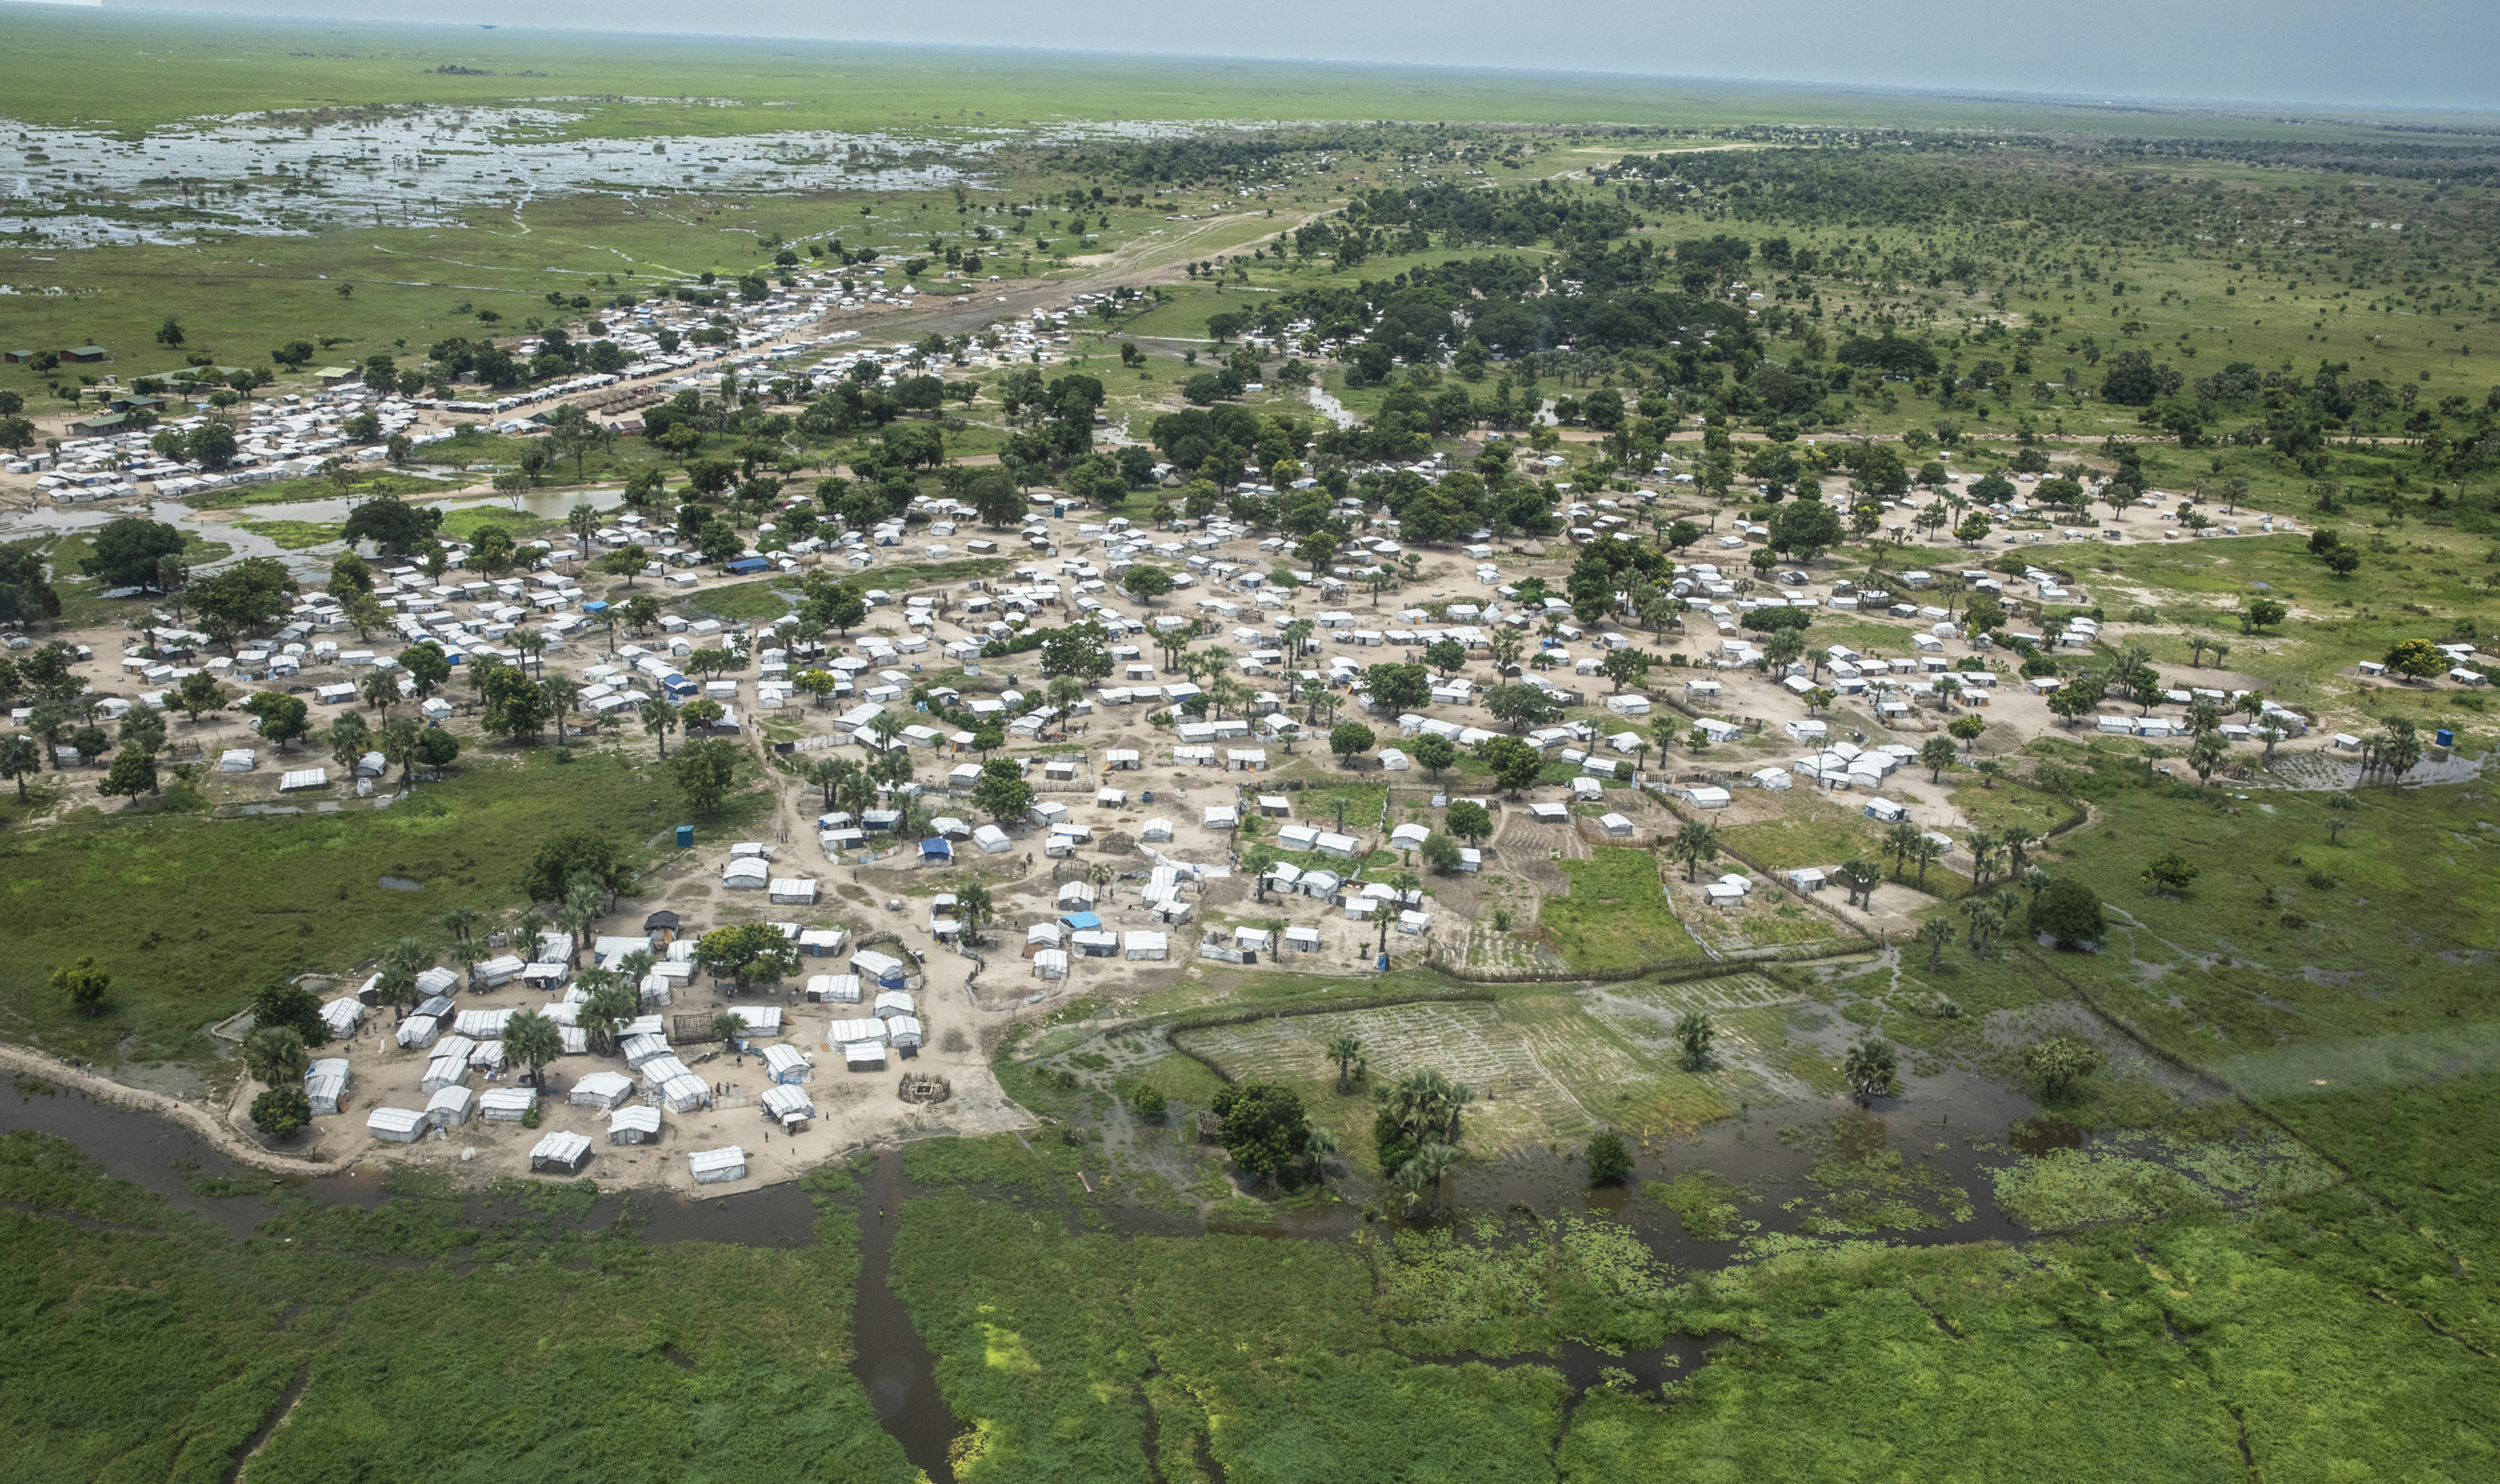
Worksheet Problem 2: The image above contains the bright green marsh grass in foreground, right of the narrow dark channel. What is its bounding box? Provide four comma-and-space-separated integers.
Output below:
875, 1109, 2500, 1479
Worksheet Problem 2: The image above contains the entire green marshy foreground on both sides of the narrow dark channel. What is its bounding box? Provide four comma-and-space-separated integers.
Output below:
0, 1074, 2500, 1482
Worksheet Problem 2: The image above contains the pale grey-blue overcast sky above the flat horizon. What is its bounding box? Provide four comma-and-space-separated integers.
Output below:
78, 0, 2500, 107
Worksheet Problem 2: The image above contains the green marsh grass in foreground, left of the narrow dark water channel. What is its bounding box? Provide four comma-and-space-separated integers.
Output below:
0, 1134, 915, 1484
